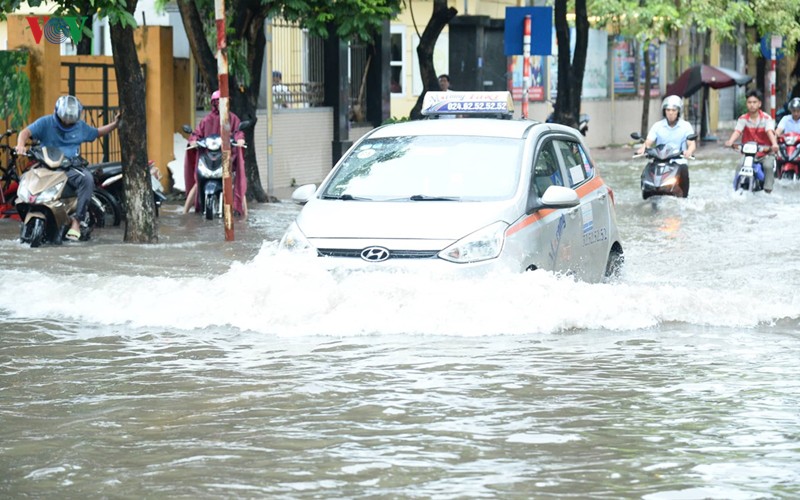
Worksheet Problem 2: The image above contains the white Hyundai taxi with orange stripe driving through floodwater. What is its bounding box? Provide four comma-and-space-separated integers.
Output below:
280, 92, 623, 281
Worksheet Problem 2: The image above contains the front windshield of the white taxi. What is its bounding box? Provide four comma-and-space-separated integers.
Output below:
322, 135, 524, 201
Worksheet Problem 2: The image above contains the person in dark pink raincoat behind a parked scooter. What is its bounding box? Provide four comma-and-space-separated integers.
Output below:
183, 90, 247, 217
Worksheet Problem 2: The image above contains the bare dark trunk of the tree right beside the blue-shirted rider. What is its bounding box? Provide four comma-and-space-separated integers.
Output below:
111, 0, 158, 243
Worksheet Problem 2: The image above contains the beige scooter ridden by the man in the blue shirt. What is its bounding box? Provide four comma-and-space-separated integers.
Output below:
16, 145, 105, 248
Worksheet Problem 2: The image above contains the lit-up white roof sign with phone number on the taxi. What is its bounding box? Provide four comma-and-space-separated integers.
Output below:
422, 91, 514, 116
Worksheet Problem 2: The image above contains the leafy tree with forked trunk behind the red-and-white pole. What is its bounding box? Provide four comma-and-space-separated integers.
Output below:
168, 0, 401, 202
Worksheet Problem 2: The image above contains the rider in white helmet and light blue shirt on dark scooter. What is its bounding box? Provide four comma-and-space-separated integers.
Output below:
636, 95, 697, 196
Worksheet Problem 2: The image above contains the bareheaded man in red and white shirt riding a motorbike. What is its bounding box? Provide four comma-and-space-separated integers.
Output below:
725, 89, 778, 193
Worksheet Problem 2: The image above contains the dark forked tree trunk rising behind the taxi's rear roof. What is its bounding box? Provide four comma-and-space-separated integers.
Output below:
553, 0, 589, 128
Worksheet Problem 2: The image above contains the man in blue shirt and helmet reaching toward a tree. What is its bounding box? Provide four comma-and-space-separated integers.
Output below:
16, 95, 120, 241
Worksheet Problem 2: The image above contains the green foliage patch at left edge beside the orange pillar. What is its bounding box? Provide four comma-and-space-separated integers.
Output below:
0, 50, 31, 129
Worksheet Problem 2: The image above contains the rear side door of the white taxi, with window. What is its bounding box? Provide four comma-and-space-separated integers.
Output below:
553, 136, 610, 279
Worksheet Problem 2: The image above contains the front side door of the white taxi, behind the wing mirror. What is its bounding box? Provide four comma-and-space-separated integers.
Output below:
526, 135, 581, 273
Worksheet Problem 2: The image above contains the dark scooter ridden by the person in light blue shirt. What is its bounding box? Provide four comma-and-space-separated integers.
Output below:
631, 132, 697, 200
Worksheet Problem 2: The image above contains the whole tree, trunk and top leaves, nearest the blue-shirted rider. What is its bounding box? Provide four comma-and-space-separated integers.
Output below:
0, 0, 158, 243
